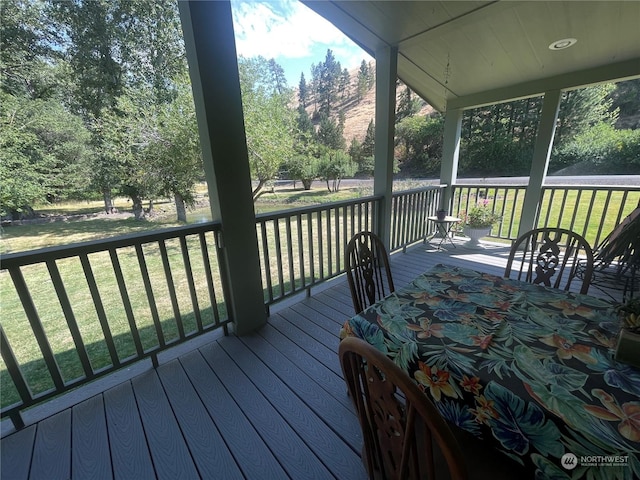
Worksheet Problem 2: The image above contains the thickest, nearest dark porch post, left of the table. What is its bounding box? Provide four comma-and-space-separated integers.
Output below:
178, 1, 267, 335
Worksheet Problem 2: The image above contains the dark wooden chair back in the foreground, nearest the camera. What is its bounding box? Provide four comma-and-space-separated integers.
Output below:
338, 337, 467, 480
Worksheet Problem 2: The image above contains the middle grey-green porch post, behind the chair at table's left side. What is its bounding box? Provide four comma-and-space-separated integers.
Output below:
373, 47, 398, 249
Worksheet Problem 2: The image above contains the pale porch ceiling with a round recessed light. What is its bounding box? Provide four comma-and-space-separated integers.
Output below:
303, 0, 640, 111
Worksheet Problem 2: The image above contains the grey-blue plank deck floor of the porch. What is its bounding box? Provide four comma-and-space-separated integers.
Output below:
0, 240, 600, 480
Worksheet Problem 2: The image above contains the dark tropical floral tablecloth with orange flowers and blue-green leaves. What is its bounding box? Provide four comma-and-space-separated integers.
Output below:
343, 265, 640, 480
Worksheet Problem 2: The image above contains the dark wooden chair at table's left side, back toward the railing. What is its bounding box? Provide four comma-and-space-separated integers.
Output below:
344, 232, 395, 313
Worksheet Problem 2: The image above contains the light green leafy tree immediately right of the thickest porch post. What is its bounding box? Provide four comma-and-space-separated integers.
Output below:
238, 57, 295, 200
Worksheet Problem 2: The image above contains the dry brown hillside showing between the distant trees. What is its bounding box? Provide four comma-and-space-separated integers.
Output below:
296, 68, 434, 146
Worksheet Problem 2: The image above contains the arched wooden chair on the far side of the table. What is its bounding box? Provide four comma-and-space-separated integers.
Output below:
504, 227, 593, 293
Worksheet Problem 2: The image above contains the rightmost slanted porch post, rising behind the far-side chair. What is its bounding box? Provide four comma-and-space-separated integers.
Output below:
518, 90, 562, 236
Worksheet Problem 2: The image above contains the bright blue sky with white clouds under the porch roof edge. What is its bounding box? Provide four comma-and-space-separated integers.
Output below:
231, 0, 372, 87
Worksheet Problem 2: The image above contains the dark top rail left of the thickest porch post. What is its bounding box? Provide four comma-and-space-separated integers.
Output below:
0, 222, 221, 270
